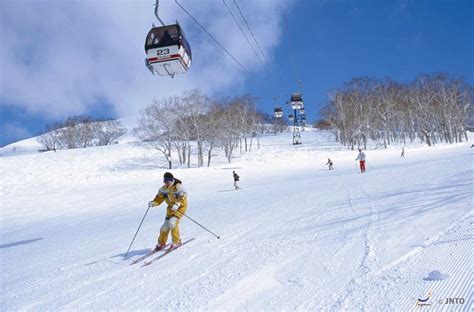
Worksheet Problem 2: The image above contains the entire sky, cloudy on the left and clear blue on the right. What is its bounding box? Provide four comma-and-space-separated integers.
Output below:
0, 0, 474, 146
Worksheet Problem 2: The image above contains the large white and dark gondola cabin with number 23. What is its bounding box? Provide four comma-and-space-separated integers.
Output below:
145, 24, 192, 77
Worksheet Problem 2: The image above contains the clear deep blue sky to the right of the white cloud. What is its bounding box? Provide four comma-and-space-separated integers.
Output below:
246, 0, 474, 114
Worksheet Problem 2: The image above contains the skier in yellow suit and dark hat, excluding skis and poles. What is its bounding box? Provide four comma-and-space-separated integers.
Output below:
148, 172, 188, 251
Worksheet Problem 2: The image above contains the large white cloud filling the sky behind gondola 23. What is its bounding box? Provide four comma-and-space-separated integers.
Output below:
0, 0, 292, 118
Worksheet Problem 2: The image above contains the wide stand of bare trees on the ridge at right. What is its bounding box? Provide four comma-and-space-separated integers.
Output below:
321, 74, 473, 148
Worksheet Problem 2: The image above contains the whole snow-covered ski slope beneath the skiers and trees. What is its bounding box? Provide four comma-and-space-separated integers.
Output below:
0, 131, 474, 311
